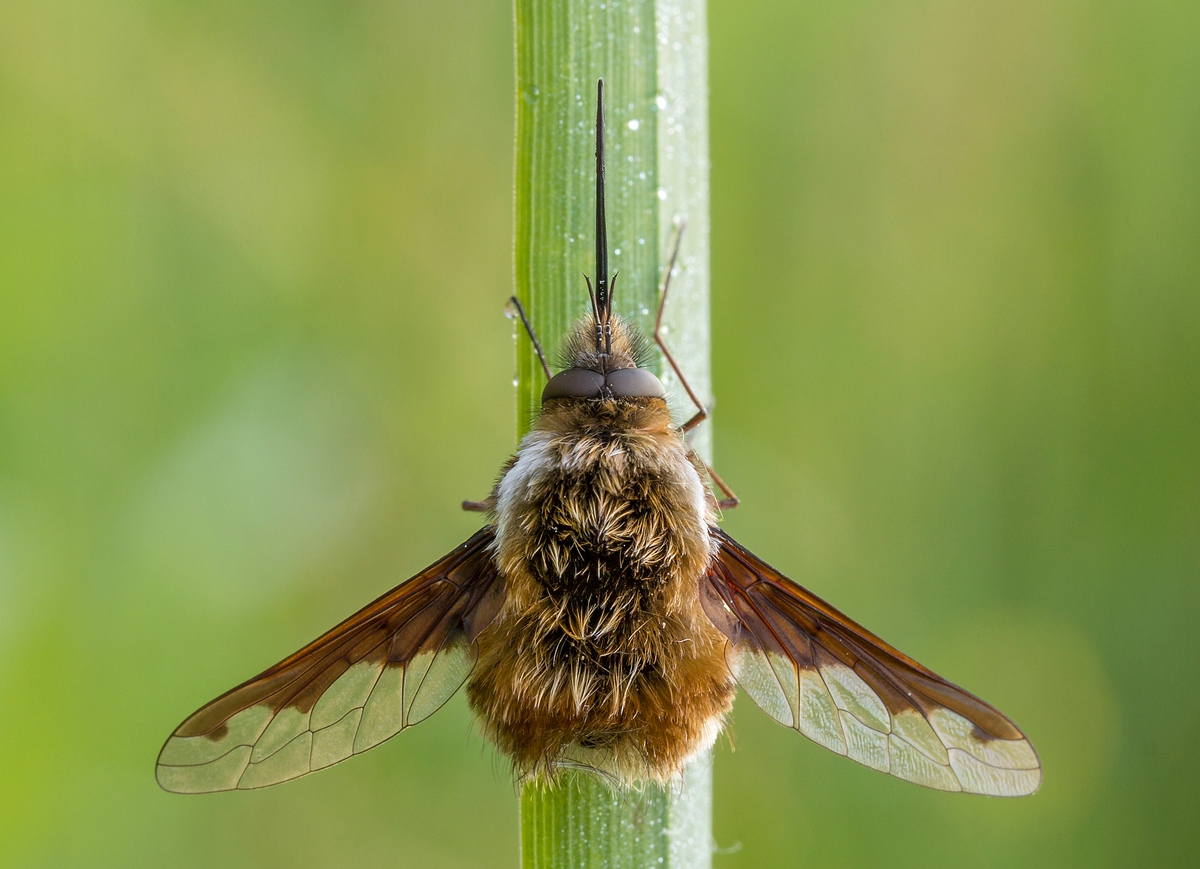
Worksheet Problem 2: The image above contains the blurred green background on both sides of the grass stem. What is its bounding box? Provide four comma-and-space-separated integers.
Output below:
0, 0, 1200, 868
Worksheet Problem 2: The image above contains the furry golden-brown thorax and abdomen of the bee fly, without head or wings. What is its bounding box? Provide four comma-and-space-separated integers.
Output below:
468, 410, 733, 781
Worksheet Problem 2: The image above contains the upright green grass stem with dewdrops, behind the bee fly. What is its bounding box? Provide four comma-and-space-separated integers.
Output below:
515, 0, 712, 869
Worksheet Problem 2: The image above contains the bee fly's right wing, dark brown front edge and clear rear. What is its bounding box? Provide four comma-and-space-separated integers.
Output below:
701, 528, 1042, 797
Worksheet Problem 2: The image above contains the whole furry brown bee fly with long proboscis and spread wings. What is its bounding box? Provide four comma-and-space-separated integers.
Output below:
157, 82, 1042, 796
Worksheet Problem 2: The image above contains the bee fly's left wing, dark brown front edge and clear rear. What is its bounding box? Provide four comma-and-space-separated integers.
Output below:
157, 528, 504, 793
